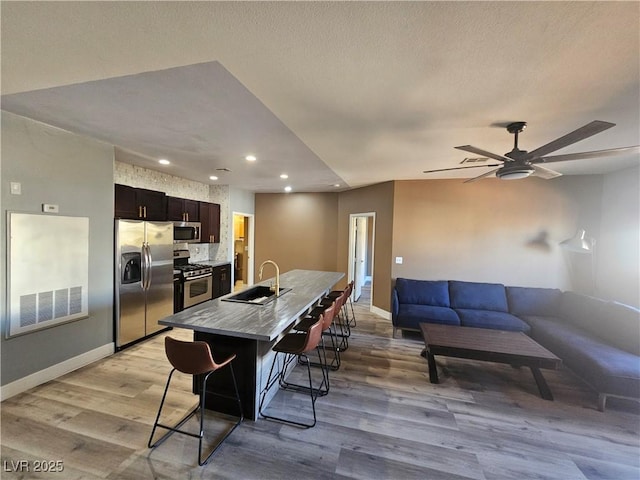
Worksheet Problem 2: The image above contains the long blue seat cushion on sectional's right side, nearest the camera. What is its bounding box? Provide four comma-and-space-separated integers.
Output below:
525, 316, 640, 398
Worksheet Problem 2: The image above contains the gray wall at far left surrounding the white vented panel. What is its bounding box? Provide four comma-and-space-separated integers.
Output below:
0, 112, 113, 385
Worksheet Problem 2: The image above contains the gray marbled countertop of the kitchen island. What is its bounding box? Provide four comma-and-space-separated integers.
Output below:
158, 270, 344, 342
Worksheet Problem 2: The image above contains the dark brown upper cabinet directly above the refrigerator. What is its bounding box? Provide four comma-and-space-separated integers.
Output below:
115, 183, 167, 221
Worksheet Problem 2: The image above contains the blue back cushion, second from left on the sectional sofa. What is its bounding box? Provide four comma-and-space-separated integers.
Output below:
449, 280, 508, 312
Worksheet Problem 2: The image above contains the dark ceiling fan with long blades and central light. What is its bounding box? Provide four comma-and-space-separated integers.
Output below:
424, 120, 640, 183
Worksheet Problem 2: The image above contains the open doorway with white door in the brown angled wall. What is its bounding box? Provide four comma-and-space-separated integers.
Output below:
347, 212, 376, 307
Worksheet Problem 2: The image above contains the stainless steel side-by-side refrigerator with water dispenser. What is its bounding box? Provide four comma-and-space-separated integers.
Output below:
114, 220, 173, 348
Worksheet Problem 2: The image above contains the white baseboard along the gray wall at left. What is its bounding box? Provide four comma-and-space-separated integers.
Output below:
0, 343, 115, 401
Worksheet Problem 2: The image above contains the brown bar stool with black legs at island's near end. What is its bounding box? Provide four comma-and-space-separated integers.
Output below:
148, 337, 244, 466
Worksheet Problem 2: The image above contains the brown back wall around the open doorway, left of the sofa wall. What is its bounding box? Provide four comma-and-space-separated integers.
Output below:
255, 182, 393, 311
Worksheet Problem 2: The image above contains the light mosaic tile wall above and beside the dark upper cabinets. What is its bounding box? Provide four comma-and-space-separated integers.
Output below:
113, 161, 231, 263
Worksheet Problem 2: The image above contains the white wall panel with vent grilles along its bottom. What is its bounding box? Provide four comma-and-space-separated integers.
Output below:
6, 212, 89, 337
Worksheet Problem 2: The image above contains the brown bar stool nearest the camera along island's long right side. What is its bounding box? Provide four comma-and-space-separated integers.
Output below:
258, 316, 327, 428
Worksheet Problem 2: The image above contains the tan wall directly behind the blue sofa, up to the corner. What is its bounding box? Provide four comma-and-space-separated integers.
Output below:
392, 175, 602, 291
